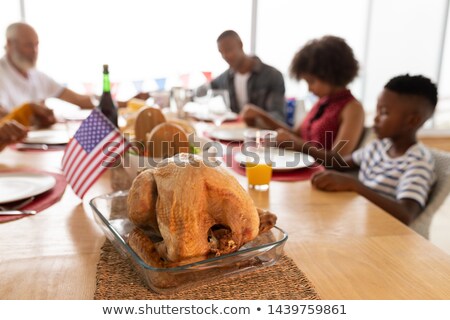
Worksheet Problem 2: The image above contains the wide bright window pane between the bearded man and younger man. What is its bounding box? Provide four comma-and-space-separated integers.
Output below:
26, 0, 251, 95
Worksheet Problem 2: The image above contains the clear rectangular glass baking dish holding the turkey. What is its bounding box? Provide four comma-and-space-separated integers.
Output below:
89, 191, 288, 293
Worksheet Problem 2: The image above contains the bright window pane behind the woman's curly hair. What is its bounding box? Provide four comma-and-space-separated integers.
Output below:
256, 0, 368, 105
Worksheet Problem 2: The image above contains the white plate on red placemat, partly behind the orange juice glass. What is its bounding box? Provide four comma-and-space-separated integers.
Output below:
234, 148, 315, 171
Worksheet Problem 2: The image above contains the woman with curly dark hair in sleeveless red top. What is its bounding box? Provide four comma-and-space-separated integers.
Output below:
243, 36, 364, 159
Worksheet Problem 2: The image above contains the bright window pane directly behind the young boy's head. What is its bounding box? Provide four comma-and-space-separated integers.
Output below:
364, 0, 446, 122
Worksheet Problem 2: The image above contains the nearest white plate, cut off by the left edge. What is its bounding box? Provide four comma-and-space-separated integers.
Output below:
0, 173, 56, 203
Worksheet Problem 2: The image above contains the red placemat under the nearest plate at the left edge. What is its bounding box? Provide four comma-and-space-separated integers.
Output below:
0, 169, 67, 223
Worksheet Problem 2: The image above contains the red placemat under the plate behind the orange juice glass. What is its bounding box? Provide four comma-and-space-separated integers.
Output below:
224, 152, 325, 181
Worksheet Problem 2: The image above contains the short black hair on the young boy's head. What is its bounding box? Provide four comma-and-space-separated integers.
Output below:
384, 74, 438, 110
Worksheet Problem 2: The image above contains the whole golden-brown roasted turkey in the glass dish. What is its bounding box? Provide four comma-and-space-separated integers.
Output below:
128, 153, 276, 267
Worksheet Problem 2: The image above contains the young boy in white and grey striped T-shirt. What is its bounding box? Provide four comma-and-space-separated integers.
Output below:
312, 74, 437, 224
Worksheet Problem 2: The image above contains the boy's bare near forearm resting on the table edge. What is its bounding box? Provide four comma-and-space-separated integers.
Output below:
311, 170, 422, 225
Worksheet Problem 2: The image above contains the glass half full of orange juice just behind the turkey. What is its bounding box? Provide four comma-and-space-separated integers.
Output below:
242, 129, 277, 191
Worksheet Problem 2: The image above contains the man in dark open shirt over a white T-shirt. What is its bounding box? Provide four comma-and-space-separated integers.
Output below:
211, 30, 285, 122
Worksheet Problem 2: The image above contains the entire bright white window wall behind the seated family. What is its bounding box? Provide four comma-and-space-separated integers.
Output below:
0, 0, 450, 132
